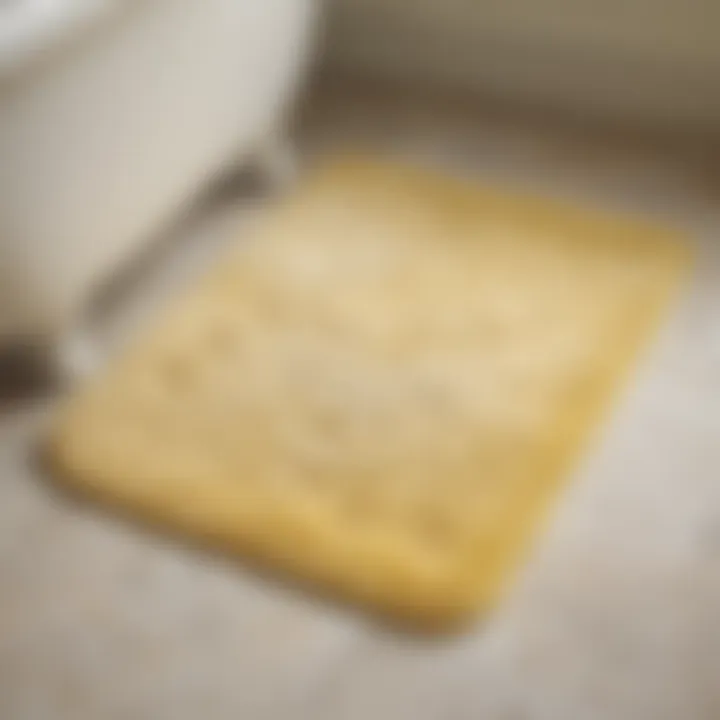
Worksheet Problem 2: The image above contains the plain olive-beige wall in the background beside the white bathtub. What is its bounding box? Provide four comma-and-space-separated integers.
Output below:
324, 0, 720, 132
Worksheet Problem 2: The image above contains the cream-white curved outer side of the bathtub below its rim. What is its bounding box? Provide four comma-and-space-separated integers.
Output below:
0, 0, 313, 338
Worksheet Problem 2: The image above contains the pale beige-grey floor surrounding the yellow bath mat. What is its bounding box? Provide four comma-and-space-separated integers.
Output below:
0, 80, 720, 720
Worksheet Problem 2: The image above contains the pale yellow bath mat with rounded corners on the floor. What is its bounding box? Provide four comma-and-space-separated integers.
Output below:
47, 159, 686, 625
